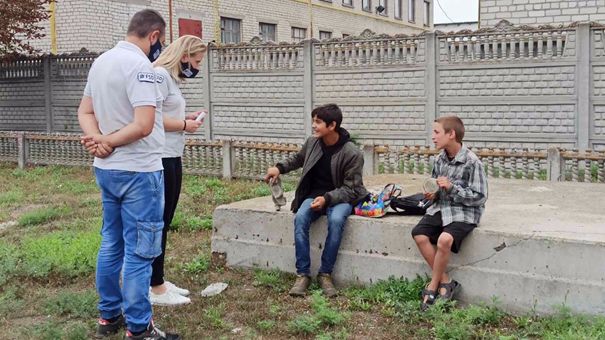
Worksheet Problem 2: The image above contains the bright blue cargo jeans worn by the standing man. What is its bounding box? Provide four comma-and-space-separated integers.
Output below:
95, 168, 164, 332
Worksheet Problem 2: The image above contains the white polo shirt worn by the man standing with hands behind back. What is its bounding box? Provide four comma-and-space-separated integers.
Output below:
84, 41, 164, 172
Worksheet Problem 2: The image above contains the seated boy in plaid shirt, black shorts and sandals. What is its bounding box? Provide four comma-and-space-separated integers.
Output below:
412, 116, 487, 310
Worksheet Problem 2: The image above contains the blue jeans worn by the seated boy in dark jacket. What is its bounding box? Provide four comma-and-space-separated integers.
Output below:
294, 198, 353, 276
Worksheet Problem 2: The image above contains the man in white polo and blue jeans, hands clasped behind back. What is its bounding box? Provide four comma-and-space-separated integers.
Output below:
78, 10, 180, 339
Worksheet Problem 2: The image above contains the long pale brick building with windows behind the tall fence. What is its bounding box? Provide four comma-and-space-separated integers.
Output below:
33, 0, 433, 54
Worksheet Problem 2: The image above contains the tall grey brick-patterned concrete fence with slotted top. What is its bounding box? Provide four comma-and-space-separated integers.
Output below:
0, 21, 605, 152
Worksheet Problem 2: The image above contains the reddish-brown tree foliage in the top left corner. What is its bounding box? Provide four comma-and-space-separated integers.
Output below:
0, 0, 51, 56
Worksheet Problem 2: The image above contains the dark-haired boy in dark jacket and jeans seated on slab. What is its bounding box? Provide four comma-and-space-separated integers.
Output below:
265, 104, 368, 297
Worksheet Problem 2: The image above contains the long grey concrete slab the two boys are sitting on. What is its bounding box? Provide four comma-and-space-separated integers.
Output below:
212, 175, 605, 314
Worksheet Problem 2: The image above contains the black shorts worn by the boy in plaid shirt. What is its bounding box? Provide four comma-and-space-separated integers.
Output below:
412, 211, 477, 253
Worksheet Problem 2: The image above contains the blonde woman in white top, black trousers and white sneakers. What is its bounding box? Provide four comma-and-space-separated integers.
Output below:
149, 35, 206, 306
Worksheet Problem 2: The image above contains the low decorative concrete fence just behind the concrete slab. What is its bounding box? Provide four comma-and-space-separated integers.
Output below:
0, 132, 605, 183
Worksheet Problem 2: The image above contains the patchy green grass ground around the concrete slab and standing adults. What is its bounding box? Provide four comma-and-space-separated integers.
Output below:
0, 163, 605, 340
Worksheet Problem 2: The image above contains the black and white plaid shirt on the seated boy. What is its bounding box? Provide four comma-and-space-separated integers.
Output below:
427, 145, 487, 226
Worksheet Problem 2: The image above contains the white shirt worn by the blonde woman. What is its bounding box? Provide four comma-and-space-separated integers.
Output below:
155, 66, 185, 158
